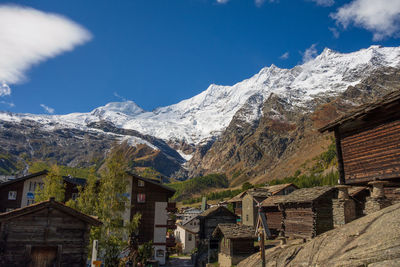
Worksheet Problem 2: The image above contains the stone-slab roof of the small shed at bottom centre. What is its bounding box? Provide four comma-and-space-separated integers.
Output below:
212, 223, 256, 239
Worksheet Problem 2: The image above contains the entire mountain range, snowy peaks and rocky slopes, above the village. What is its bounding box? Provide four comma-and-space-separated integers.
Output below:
0, 46, 400, 184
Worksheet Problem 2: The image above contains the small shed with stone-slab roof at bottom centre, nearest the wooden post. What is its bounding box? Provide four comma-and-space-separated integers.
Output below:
213, 223, 257, 267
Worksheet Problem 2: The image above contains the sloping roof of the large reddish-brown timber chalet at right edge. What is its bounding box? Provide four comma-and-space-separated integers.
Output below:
318, 90, 400, 133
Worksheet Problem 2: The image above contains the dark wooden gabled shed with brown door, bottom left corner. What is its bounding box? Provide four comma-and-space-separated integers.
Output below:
0, 198, 102, 267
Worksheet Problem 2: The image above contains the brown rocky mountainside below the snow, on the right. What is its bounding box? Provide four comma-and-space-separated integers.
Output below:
189, 68, 400, 185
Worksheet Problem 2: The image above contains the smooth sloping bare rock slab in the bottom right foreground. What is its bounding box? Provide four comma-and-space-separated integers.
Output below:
238, 204, 400, 267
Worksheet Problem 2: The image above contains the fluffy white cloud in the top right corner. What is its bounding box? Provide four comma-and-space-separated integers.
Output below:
330, 0, 400, 41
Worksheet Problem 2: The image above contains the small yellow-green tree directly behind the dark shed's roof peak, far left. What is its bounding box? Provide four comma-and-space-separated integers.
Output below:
35, 165, 65, 202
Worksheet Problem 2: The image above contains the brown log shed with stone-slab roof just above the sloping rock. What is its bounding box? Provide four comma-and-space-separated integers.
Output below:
275, 186, 337, 239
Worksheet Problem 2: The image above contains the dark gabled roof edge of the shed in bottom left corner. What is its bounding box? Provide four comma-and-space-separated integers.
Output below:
0, 198, 103, 226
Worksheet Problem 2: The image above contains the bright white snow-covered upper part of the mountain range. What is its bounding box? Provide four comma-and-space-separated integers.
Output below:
0, 46, 400, 145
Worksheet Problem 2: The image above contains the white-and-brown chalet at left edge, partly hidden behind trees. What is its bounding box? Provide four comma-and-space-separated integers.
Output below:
0, 170, 86, 213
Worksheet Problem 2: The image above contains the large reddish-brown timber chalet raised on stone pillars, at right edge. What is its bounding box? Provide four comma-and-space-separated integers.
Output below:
319, 90, 400, 194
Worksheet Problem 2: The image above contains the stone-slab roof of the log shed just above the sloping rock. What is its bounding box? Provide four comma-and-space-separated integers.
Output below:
275, 186, 337, 204
